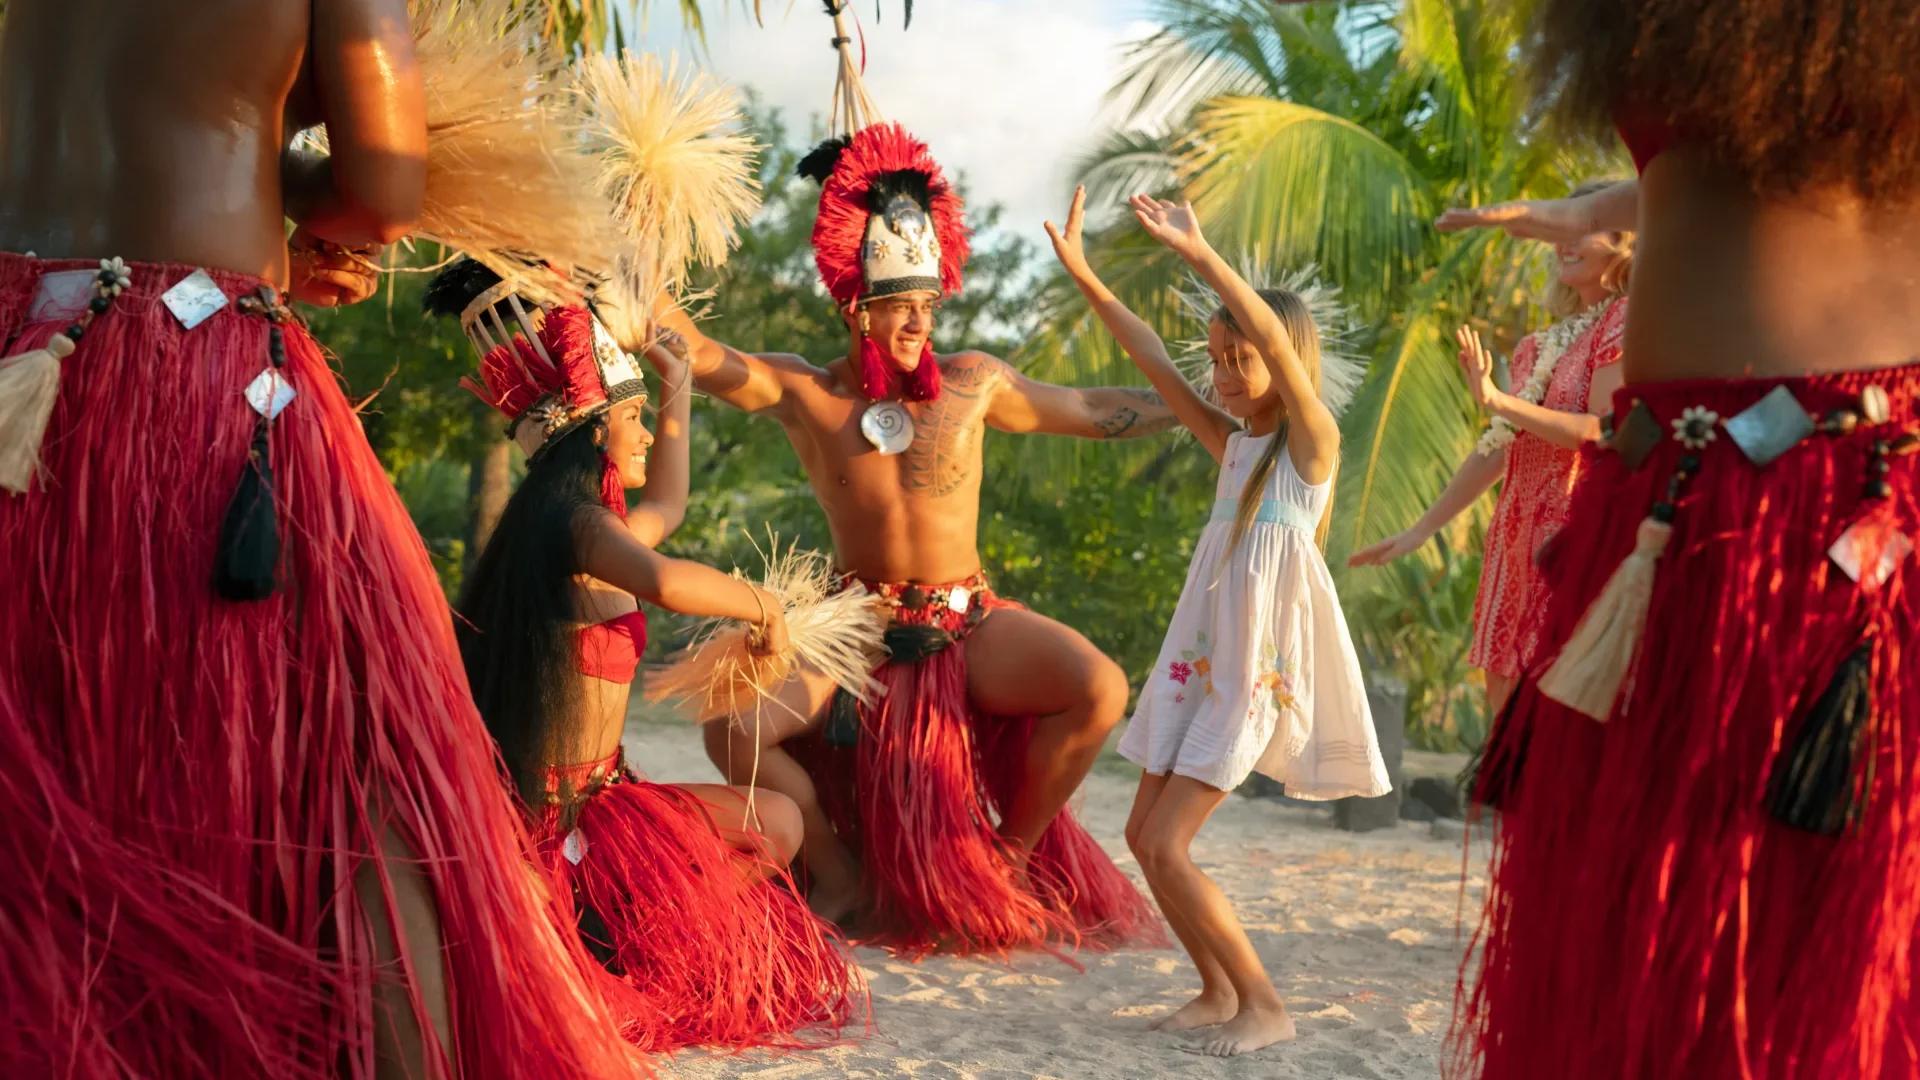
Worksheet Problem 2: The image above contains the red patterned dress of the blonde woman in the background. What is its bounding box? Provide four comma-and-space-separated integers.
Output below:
1467, 296, 1626, 678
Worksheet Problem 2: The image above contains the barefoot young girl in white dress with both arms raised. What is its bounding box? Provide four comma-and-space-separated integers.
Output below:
1046, 192, 1388, 1057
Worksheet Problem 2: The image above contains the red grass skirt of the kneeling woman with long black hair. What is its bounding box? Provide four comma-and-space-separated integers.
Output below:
538, 755, 868, 1051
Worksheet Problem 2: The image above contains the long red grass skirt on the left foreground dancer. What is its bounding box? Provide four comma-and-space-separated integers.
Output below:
0, 254, 634, 1080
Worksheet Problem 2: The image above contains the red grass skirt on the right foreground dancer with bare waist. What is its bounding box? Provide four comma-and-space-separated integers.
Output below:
1453, 365, 1920, 1080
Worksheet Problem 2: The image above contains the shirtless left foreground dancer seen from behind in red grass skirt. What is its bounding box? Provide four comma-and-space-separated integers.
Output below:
0, 0, 632, 1080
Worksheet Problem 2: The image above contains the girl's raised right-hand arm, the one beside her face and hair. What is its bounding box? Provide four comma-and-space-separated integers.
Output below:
1131, 194, 1340, 484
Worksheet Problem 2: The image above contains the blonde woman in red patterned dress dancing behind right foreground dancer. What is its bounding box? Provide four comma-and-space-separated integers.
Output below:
1348, 193, 1634, 713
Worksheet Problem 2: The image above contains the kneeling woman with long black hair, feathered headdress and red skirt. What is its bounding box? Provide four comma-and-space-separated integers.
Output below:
426, 261, 864, 1051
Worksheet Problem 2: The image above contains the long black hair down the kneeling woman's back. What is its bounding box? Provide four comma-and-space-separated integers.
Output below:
455, 417, 607, 807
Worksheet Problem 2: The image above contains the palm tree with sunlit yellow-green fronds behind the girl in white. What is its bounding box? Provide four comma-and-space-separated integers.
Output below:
1025, 0, 1617, 737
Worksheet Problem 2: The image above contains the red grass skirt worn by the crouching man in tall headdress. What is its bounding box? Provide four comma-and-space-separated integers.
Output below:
793, 575, 1165, 957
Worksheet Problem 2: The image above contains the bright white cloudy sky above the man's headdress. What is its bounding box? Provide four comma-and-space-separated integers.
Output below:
639, 0, 1152, 248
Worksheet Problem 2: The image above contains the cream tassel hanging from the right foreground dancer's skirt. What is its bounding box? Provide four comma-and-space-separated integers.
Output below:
1540, 517, 1674, 723
